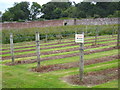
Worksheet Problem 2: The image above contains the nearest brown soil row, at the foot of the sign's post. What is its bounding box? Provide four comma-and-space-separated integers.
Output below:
62, 68, 120, 87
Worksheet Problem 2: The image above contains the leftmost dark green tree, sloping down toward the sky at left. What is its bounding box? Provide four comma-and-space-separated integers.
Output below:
2, 2, 30, 21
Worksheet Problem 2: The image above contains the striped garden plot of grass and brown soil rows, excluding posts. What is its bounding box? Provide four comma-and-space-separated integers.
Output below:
3, 36, 119, 88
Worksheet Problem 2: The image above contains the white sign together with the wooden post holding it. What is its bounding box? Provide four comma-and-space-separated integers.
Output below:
75, 32, 84, 81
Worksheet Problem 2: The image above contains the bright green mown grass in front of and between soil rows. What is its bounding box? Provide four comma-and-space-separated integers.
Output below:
2, 34, 118, 88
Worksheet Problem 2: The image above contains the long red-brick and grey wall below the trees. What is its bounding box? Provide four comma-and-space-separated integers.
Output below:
0, 18, 118, 29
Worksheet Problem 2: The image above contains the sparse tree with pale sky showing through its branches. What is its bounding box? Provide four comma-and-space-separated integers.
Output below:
30, 2, 41, 20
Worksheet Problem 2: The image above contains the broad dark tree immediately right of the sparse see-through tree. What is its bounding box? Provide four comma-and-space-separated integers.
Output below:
41, 2, 72, 19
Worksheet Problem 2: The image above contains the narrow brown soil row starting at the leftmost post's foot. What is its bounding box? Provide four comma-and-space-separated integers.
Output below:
6, 47, 118, 65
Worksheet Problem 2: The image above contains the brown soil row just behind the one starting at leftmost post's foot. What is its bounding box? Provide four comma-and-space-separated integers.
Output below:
2, 42, 116, 60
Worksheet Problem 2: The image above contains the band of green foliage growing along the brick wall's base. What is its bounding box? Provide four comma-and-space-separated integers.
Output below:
2, 25, 117, 43
